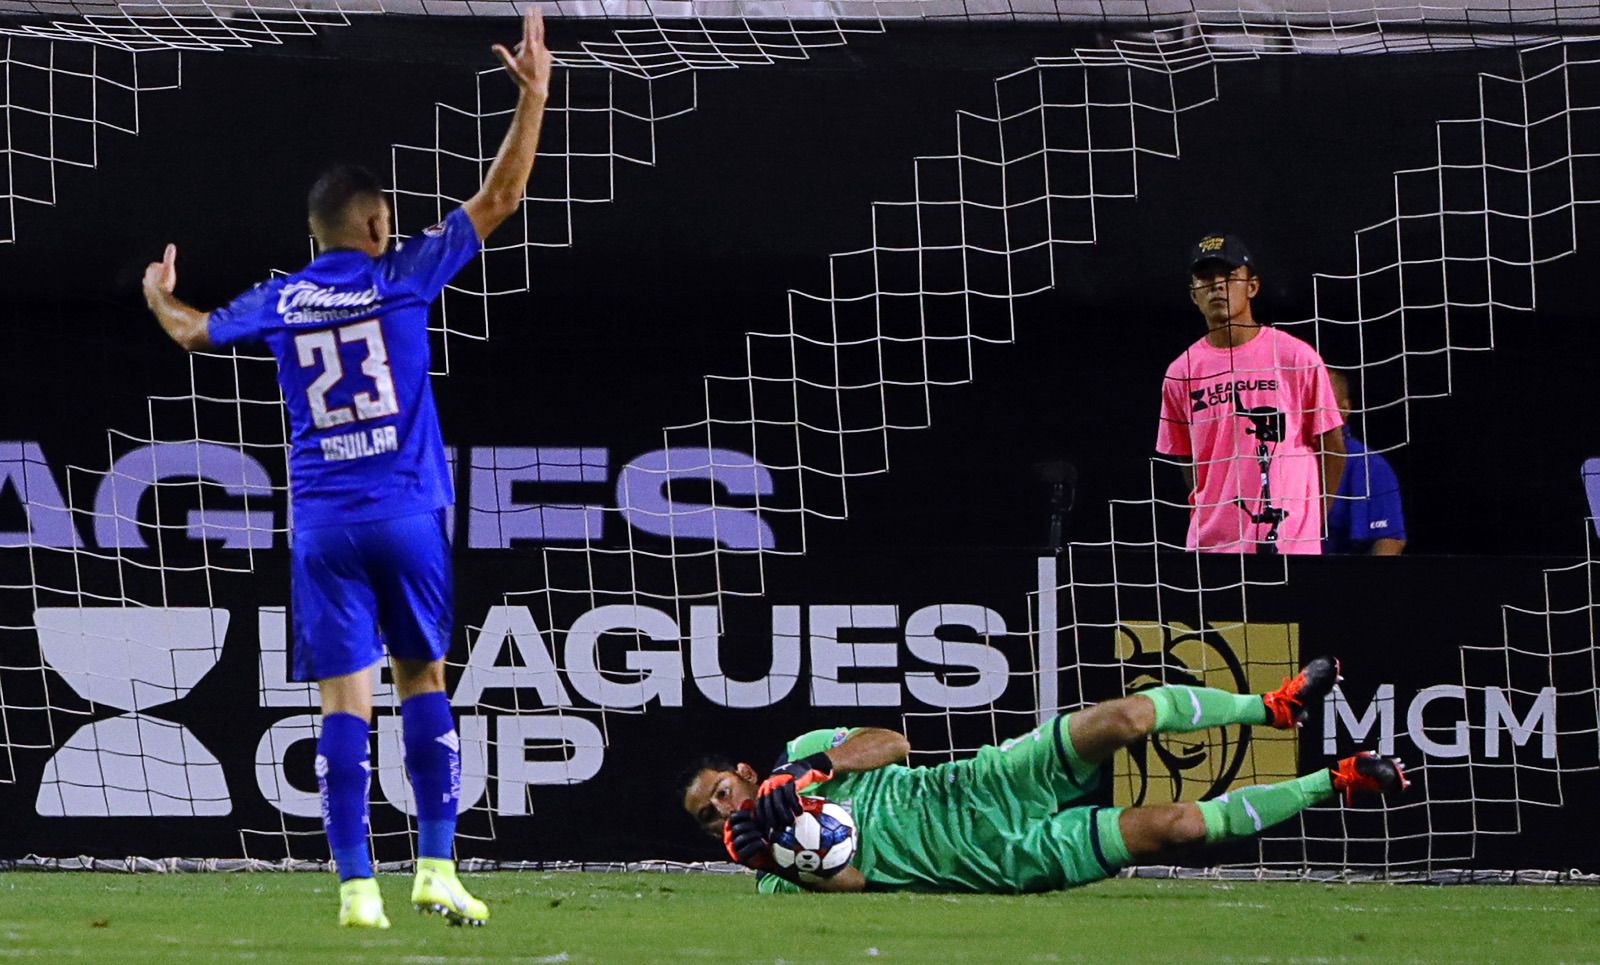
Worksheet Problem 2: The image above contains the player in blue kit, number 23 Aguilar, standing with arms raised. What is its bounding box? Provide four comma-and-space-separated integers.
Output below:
144, 10, 552, 928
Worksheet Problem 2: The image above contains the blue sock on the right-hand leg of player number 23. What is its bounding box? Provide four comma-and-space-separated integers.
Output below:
400, 691, 461, 859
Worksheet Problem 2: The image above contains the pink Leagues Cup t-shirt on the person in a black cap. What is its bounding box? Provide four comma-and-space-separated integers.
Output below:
1155, 328, 1344, 554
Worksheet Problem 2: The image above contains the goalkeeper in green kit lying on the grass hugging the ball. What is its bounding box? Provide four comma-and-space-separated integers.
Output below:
678, 656, 1408, 893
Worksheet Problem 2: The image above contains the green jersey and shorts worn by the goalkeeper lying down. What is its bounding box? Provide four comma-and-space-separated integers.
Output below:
758, 728, 1115, 893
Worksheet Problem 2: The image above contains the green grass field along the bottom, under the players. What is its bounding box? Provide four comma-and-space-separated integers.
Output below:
0, 872, 1600, 965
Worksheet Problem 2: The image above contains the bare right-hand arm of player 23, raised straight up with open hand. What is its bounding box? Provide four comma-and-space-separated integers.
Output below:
462, 8, 552, 240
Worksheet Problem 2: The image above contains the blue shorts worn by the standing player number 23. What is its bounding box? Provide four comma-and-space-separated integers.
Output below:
290, 506, 454, 680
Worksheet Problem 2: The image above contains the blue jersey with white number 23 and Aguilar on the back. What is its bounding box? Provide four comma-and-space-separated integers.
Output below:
208, 208, 480, 527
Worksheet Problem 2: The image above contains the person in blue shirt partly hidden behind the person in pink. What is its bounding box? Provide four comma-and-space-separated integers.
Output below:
1322, 368, 1405, 557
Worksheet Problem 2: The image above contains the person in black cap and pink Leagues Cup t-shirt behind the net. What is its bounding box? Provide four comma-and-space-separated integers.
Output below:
1155, 234, 1344, 554
